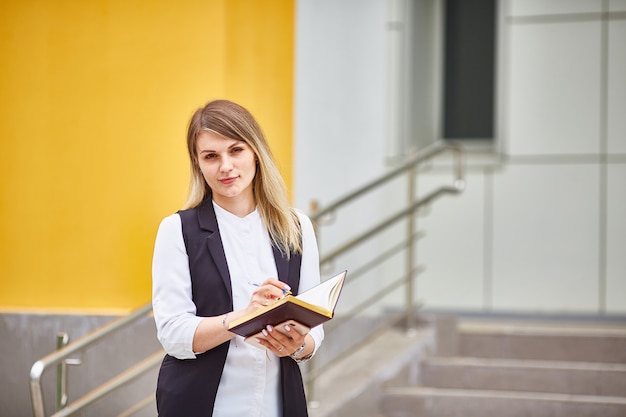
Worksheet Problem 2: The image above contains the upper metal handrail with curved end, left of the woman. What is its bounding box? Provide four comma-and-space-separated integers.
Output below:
30, 304, 157, 417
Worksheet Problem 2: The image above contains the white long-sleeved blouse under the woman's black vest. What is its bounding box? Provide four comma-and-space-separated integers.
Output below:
152, 202, 324, 417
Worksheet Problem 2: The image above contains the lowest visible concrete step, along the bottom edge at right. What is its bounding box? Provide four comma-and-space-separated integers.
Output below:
379, 387, 626, 417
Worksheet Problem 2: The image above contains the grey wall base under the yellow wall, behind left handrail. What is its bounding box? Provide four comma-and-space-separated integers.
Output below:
0, 314, 160, 417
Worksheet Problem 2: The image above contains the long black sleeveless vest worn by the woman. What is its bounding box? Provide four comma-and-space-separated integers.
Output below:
156, 198, 308, 417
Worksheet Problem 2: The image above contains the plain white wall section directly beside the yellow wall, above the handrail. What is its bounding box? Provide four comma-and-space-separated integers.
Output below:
294, 0, 387, 209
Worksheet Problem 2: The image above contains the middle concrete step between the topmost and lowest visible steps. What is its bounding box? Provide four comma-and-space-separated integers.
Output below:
420, 357, 626, 397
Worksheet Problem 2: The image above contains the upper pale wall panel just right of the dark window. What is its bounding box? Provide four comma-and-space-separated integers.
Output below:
507, 22, 601, 155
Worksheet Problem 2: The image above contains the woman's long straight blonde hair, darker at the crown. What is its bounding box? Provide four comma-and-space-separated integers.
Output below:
184, 100, 302, 256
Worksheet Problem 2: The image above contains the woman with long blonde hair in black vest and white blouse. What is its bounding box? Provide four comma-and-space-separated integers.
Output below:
152, 100, 324, 417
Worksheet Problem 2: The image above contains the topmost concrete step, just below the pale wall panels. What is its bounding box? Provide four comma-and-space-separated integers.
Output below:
458, 323, 626, 364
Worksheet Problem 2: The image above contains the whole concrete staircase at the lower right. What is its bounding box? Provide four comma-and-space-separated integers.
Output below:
379, 320, 626, 417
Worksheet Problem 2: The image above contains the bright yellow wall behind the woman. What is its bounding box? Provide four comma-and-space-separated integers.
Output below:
0, 0, 294, 312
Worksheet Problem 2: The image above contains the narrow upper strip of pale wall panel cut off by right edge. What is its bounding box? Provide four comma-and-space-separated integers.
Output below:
607, 20, 626, 153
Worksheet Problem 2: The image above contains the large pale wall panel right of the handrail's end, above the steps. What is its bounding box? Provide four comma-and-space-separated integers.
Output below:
493, 165, 599, 312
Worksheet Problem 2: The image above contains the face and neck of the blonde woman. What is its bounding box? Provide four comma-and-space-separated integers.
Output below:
196, 131, 256, 209
